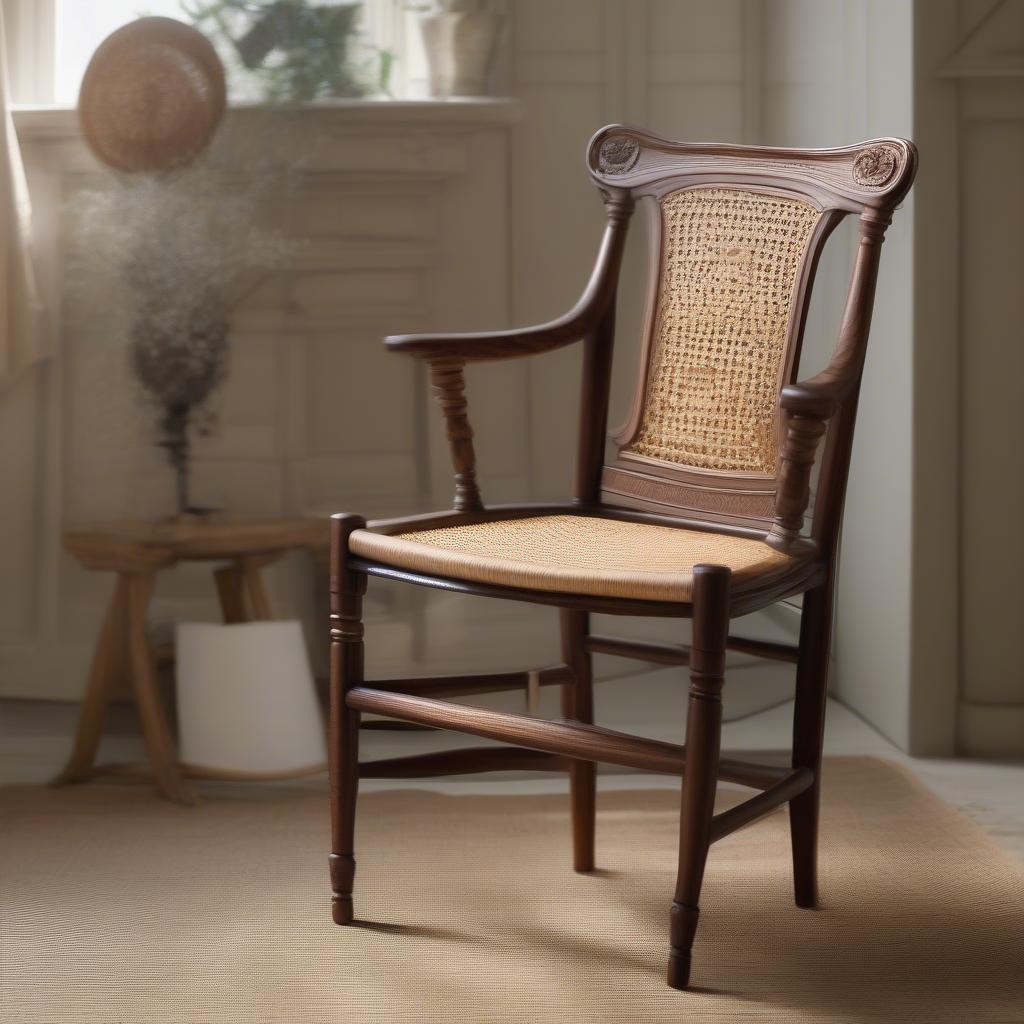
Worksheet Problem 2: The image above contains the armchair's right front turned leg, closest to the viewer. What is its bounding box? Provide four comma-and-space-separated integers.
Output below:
669, 565, 731, 988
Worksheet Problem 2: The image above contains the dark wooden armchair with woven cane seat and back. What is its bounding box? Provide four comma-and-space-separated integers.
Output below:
330, 125, 918, 988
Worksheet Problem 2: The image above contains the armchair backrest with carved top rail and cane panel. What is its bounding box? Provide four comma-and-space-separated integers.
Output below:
588, 125, 915, 527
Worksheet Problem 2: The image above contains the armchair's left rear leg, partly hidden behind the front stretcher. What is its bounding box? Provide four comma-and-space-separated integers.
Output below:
559, 608, 597, 871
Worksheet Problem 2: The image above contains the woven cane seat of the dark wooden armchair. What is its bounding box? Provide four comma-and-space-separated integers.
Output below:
349, 515, 794, 601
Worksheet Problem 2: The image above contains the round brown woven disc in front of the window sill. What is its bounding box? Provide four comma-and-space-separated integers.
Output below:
78, 17, 226, 171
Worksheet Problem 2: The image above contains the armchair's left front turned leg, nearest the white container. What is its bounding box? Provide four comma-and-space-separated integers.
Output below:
328, 514, 367, 925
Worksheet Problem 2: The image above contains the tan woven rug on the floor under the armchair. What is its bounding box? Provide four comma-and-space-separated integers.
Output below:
0, 759, 1024, 1024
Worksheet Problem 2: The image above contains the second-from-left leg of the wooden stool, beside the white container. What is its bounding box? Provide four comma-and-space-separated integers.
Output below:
128, 573, 196, 804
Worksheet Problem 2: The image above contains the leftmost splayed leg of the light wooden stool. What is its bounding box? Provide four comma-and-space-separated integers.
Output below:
53, 574, 128, 785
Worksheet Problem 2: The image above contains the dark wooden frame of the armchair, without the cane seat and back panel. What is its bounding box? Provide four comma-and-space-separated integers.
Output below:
329, 125, 916, 988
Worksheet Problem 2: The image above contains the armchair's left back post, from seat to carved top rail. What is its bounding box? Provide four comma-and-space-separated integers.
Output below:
572, 188, 635, 506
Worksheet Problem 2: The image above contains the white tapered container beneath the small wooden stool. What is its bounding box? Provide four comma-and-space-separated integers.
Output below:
176, 622, 327, 778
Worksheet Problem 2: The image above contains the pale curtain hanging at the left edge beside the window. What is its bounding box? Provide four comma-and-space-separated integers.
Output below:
0, 5, 47, 387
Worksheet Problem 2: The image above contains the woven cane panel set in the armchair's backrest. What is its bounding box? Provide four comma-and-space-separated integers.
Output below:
623, 187, 821, 476
